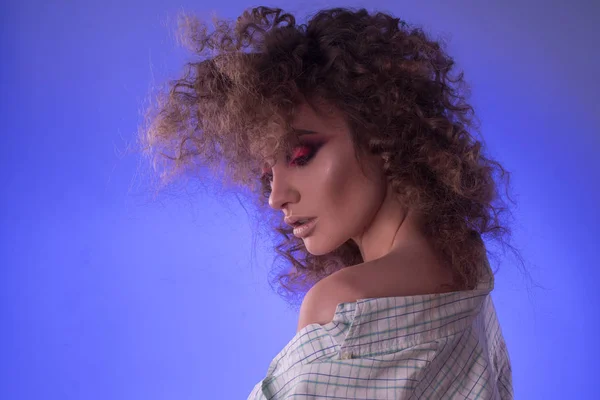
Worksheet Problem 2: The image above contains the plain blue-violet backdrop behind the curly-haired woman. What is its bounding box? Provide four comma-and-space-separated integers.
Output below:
0, 0, 600, 400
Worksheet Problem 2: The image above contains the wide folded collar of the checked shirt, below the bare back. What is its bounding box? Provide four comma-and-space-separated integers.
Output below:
323, 260, 494, 357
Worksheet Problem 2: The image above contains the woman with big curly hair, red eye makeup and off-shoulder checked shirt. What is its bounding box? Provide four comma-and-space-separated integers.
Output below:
142, 7, 512, 399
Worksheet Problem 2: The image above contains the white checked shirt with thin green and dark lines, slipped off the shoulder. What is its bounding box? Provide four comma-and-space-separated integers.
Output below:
248, 263, 513, 400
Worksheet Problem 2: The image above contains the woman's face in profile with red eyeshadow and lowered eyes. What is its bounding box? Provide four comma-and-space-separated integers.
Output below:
265, 103, 387, 255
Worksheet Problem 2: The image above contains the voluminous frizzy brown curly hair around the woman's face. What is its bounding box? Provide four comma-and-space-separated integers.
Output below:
140, 7, 510, 306
